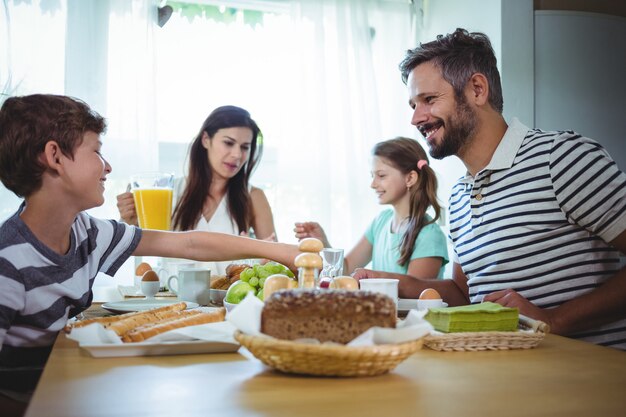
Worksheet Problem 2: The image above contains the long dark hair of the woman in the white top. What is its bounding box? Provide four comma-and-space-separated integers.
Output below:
173, 106, 263, 232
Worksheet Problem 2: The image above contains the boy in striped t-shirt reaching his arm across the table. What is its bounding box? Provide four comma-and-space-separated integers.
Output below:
0, 94, 299, 406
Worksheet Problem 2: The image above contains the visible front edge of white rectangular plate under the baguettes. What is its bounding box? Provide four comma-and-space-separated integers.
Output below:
80, 340, 239, 358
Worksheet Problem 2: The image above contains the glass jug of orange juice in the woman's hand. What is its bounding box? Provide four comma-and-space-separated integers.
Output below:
131, 172, 174, 230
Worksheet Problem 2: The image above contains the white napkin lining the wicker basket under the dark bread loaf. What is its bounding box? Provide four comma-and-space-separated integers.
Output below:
226, 294, 433, 346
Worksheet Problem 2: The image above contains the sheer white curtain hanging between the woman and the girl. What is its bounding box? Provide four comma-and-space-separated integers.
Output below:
275, 1, 382, 249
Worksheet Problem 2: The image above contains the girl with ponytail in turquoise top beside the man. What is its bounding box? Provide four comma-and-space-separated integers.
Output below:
294, 138, 448, 296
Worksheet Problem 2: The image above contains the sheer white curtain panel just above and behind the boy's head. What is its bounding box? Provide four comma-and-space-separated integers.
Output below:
77, 0, 159, 218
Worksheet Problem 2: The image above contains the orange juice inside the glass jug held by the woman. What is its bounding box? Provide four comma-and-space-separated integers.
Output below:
133, 188, 172, 230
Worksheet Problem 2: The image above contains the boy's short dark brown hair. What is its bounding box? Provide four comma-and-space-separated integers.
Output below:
0, 94, 106, 197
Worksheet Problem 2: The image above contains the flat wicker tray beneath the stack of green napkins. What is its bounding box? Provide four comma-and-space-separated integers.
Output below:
424, 314, 550, 351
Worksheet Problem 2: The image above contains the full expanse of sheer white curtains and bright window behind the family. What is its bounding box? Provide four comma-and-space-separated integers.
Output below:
0, 0, 417, 280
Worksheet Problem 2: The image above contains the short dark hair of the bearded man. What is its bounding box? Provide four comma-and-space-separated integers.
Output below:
399, 28, 503, 113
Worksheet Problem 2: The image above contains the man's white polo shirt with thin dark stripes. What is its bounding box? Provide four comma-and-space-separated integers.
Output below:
450, 120, 626, 349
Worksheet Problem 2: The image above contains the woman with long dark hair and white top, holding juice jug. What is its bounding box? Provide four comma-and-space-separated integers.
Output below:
117, 106, 276, 274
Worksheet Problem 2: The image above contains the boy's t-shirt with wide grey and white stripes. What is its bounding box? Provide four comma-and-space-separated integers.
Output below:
0, 205, 141, 390
